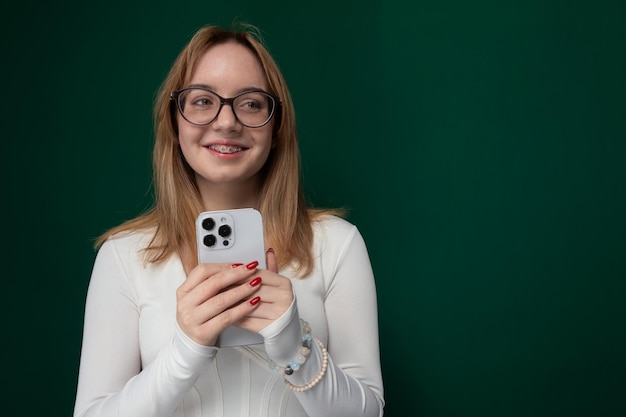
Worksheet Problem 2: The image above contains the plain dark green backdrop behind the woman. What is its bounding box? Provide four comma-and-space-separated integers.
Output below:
0, 0, 626, 417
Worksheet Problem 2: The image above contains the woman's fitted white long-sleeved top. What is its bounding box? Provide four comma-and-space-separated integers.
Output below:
74, 216, 384, 417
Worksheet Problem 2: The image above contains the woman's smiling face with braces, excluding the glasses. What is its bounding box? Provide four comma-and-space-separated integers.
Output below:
177, 42, 273, 200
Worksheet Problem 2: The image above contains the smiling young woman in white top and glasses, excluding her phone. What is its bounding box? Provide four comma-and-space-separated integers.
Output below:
74, 26, 384, 417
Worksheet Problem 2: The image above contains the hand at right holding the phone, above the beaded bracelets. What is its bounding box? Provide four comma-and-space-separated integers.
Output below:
237, 249, 293, 333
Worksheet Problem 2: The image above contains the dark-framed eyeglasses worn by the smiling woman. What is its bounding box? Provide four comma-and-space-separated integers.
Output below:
170, 87, 280, 127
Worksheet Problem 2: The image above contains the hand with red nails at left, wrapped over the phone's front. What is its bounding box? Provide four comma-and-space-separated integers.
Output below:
176, 261, 261, 346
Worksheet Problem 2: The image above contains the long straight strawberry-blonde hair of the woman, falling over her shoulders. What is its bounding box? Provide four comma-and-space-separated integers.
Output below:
96, 25, 343, 277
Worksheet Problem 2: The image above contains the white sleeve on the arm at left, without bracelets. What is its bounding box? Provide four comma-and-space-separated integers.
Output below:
74, 237, 216, 417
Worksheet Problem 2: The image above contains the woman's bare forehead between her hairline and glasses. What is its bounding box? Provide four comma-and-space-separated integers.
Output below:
190, 42, 268, 94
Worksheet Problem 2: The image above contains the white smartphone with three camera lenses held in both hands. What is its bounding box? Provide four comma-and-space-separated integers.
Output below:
196, 208, 267, 348
